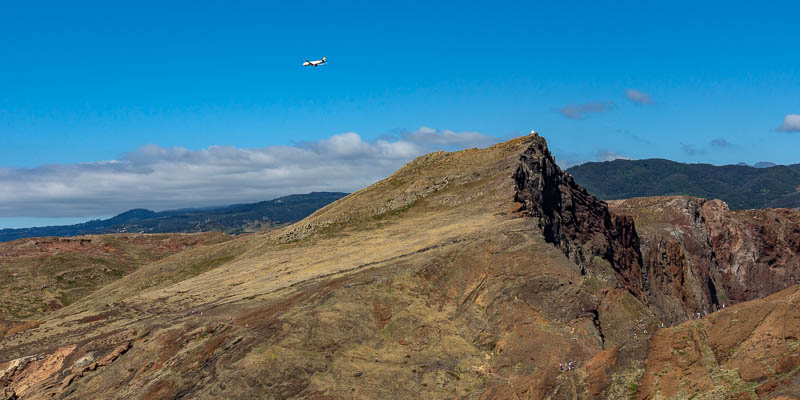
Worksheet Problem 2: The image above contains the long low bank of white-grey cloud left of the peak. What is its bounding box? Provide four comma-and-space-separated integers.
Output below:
0, 127, 498, 217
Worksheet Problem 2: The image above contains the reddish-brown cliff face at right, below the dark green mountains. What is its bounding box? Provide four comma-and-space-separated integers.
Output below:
610, 197, 800, 322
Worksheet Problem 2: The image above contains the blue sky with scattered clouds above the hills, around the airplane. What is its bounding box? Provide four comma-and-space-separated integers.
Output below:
0, 1, 800, 227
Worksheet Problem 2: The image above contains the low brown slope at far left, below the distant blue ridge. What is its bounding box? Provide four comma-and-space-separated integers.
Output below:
0, 232, 231, 324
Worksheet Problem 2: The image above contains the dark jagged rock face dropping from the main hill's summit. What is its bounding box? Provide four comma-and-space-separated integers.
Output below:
514, 136, 648, 301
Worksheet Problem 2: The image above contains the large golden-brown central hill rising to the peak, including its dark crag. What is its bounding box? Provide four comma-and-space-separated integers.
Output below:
0, 135, 800, 399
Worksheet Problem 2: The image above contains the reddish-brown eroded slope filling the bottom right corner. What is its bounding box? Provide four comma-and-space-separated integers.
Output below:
587, 286, 800, 400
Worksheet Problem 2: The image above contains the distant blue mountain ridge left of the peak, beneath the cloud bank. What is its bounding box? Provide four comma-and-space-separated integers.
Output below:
0, 192, 347, 242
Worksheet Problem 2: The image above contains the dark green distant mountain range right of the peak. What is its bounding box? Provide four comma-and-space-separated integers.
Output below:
567, 159, 800, 209
